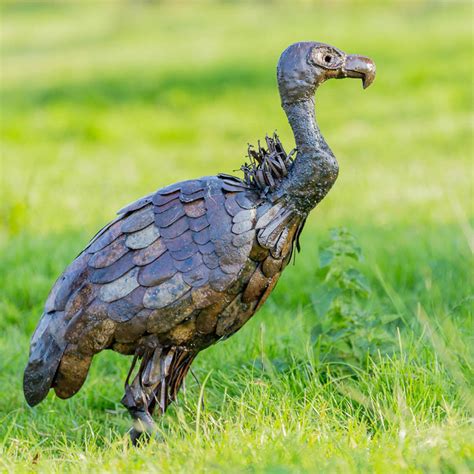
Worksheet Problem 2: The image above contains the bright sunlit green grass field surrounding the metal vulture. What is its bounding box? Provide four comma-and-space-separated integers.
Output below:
0, 1, 474, 473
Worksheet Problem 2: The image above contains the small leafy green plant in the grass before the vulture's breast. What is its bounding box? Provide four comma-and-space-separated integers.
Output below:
311, 228, 398, 371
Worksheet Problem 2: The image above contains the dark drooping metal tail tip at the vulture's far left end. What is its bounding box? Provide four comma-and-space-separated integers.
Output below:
23, 311, 67, 407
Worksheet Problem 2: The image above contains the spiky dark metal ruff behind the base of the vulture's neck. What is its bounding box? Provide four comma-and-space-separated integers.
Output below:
240, 133, 296, 194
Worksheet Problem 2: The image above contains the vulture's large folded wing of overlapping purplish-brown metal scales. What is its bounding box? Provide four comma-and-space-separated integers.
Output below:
25, 177, 258, 404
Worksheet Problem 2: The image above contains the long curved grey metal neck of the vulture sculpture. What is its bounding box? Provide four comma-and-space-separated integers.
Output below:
283, 97, 339, 214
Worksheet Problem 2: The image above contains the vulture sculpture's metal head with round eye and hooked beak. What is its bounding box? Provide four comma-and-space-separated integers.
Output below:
277, 41, 375, 105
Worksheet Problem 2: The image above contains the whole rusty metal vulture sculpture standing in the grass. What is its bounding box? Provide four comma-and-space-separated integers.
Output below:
24, 42, 375, 442
